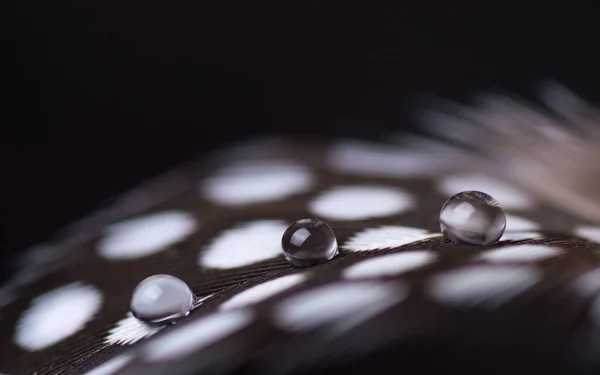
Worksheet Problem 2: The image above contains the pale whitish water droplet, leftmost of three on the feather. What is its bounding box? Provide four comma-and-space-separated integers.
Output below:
131, 275, 196, 324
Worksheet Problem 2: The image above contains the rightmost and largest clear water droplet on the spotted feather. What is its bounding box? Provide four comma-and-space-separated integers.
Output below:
440, 191, 506, 245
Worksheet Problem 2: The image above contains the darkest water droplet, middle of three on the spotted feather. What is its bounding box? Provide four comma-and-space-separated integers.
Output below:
281, 219, 338, 267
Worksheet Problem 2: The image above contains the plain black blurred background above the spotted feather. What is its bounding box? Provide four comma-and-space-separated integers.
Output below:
0, 0, 600, 280
